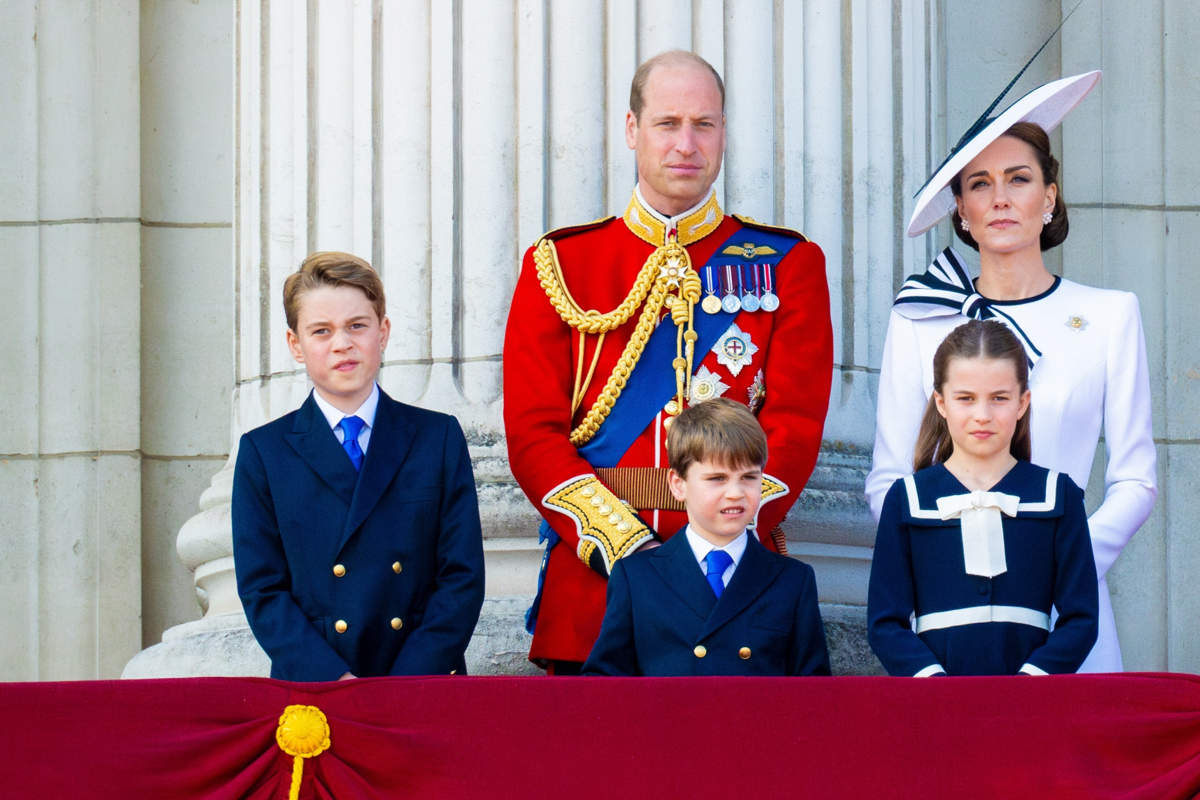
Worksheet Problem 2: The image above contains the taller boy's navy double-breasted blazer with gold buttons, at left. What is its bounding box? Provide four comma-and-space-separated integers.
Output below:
233, 390, 484, 681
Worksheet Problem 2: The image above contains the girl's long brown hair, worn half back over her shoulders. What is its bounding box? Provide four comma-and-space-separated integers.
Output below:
912, 319, 1031, 471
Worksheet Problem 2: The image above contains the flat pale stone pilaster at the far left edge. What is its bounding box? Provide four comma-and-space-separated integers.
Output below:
0, 0, 142, 680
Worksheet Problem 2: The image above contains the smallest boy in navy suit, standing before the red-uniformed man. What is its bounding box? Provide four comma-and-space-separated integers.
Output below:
583, 398, 829, 675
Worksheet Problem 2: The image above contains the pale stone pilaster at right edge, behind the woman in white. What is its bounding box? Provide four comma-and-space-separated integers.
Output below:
1062, 0, 1200, 672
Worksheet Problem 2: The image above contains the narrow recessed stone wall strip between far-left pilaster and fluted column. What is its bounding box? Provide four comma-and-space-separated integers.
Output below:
140, 2, 234, 662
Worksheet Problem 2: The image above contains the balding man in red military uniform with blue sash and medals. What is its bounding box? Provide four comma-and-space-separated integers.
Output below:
504, 50, 833, 674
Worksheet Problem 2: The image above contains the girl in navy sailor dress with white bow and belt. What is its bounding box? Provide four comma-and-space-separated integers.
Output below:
868, 320, 1098, 676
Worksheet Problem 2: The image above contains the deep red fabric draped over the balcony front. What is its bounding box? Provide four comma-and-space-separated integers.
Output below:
0, 674, 1200, 800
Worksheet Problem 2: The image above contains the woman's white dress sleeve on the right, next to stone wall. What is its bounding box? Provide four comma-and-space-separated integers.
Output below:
1094, 293, 1158, 578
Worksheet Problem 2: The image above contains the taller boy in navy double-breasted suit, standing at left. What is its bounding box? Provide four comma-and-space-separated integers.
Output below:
233, 252, 484, 681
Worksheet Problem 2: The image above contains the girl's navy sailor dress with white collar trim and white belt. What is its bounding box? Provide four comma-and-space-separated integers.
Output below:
866, 461, 1098, 675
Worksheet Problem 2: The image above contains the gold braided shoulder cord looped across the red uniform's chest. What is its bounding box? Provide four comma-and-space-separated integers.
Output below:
533, 236, 703, 447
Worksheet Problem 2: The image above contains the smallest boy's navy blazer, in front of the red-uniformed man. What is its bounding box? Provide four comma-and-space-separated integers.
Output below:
583, 531, 829, 675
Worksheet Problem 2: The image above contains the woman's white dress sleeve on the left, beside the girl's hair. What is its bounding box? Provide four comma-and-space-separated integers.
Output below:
866, 311, 928, 523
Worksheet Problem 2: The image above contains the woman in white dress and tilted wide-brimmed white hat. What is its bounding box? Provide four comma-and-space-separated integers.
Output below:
866, 72, 1157, 672
